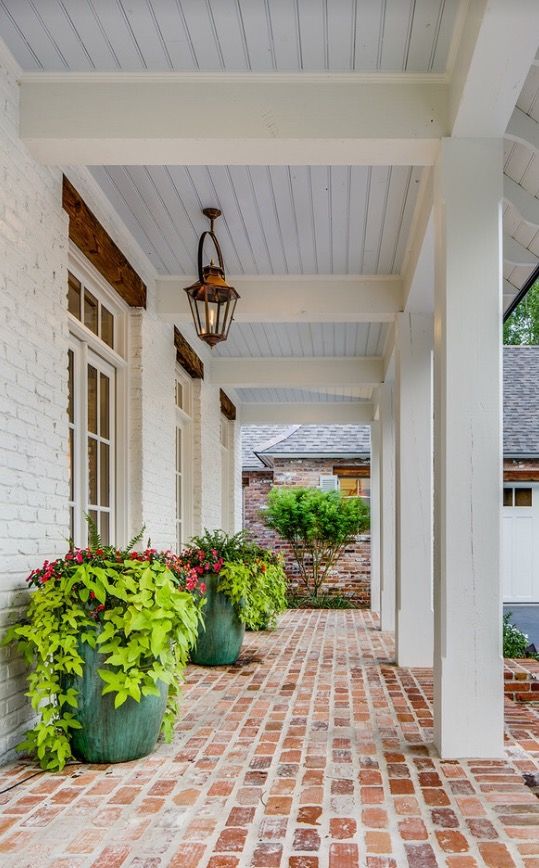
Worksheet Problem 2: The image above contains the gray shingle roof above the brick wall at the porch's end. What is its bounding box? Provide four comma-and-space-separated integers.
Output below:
241, 425, 370, 470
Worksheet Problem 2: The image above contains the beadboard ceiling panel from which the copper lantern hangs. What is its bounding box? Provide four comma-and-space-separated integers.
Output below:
91, 166, 422, 274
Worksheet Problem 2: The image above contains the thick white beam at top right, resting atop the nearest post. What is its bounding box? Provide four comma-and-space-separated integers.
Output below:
449, 0, 539, 137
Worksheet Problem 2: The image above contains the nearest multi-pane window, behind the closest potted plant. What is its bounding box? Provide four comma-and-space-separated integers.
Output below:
68, 254, 125, 546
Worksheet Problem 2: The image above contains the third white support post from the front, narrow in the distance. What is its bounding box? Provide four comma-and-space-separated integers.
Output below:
380, 382, 395, 630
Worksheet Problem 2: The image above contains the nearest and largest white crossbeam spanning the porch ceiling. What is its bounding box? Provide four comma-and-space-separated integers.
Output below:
20, 72, 448, 166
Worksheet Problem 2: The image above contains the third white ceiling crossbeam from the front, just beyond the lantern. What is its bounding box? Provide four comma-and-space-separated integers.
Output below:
206, 356, 383, 389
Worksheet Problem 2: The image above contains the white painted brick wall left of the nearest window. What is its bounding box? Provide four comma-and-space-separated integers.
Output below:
0, 44, 69, 759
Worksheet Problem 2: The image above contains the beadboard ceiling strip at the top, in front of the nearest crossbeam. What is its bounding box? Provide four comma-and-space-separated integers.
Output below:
0, 0, 459, 72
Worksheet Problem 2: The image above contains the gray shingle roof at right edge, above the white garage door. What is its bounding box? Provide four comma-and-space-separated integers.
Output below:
503, 346, 539, 456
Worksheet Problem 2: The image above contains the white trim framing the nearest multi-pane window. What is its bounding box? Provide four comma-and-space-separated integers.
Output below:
67, 241, 129, 545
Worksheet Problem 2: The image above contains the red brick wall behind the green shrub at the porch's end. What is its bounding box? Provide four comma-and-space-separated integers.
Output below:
243, 458, 371, 607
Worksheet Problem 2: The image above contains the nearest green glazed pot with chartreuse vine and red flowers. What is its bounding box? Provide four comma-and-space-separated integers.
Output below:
3, 529, 205, 770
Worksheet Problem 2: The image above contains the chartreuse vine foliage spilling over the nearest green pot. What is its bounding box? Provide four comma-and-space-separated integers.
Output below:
3, 528, 205, 770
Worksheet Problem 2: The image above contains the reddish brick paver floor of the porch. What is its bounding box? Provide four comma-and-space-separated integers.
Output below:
0, 611, 539, 868
